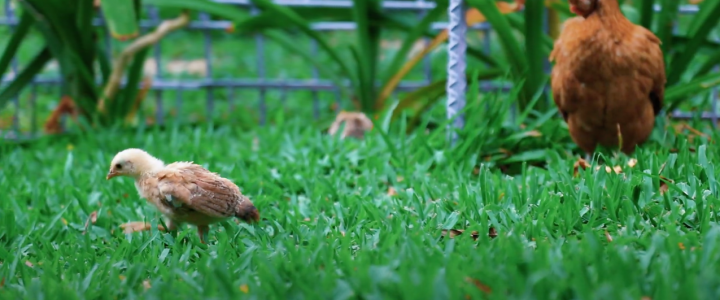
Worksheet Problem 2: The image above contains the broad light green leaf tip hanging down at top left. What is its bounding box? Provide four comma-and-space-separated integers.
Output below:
100, 0, 139, 41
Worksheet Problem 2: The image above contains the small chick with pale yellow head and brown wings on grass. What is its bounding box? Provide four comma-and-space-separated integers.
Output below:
106, 148, 260, 243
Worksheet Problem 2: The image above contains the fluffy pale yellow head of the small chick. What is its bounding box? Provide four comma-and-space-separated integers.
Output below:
105, 148, 165, 180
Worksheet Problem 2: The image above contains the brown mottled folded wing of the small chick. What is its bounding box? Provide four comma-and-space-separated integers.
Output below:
157, 162, 243, 218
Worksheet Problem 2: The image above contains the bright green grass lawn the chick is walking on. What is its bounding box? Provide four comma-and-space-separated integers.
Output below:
0, 112, 720, 299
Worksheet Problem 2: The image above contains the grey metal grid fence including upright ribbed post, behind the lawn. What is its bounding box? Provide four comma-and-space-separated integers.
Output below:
0, 0, 717, 141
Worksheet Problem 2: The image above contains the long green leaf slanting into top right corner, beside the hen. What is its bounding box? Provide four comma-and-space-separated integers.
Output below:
667, 1, 720, 86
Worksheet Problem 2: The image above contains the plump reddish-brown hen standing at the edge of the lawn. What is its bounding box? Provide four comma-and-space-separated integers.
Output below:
550, 0, 666, 154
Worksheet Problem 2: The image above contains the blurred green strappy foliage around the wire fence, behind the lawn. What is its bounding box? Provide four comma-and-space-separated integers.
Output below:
0, 0, 720, 161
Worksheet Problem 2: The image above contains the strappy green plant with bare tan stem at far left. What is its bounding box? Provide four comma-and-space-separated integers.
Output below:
0, 0, 188, 132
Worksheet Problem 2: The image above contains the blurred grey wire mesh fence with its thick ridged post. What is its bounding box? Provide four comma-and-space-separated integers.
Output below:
0, 0, 718, 138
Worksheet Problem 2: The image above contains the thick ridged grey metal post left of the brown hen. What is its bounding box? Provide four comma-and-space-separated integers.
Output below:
446, 0, 467, 145
